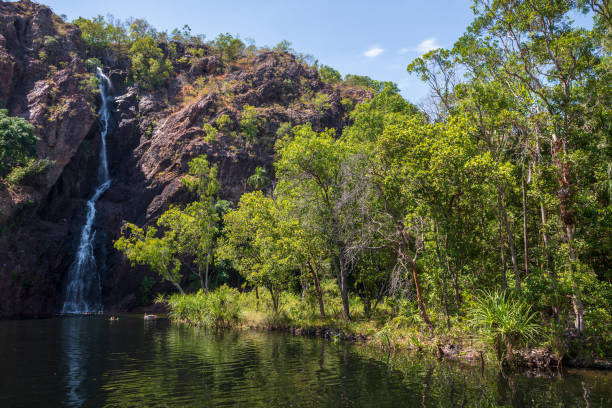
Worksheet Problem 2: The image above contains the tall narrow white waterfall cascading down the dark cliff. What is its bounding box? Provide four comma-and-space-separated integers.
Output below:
61, 68, 114, 314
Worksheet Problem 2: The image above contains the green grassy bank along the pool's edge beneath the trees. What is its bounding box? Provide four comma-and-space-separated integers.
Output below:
158, 283, 609, 368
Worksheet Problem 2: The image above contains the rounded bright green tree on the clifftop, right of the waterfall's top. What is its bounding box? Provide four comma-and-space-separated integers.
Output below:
128, 36, 174, 90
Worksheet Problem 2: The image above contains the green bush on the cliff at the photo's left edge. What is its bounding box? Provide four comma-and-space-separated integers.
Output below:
0, 109, 38, 178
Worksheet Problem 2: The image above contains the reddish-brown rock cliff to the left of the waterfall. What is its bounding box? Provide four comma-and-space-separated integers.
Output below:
0, 2, 96, 316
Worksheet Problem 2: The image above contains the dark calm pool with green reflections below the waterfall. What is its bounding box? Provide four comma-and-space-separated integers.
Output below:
0, 315, 612, 408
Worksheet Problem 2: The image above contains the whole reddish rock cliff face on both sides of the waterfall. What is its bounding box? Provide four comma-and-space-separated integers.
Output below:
0, 2, 371, 317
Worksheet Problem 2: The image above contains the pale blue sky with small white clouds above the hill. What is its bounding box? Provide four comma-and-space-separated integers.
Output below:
41, 0, 473, 103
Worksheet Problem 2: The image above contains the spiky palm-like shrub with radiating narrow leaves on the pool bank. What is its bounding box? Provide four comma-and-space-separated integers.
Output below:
469, 291, 541, 362
